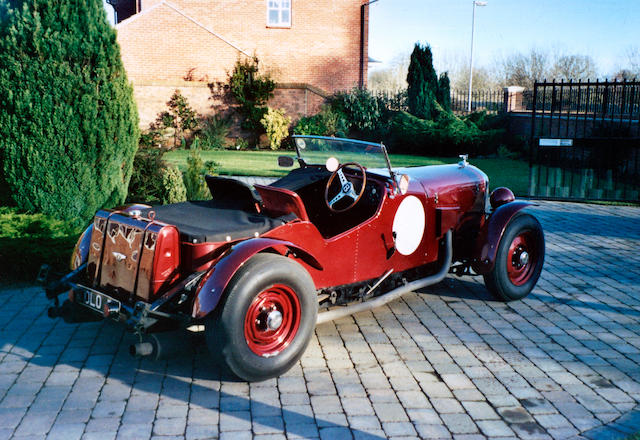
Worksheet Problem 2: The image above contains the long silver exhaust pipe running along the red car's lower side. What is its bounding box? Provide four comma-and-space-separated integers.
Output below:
316, 230, 453, 325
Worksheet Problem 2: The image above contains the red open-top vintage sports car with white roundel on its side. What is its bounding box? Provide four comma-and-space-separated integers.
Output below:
41, 136, 545, 381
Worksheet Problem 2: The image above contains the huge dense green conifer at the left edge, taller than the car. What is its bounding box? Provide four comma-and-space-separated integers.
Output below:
0, 0, 139, 224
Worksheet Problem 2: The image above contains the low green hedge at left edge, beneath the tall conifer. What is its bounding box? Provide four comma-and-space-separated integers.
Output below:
0, 207, 81, 281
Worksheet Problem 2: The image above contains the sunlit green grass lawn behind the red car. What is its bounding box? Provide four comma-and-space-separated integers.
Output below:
164, 150, 529, 195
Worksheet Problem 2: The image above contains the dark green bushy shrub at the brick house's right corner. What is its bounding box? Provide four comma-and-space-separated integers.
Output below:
329, 88, 383, 131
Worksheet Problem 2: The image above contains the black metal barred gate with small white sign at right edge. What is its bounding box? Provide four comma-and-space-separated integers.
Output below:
529, 81, 640, 202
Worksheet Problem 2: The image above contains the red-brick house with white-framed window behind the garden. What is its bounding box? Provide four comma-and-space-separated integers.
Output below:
108, 0, 368, 127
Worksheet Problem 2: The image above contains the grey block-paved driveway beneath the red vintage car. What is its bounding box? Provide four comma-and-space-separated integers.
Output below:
0, 202, 640, 440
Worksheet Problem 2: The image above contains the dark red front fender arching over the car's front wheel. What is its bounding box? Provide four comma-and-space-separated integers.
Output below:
472, 200, 533, 274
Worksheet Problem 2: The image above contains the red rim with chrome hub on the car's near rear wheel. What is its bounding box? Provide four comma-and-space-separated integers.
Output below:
244, 284, 300, 357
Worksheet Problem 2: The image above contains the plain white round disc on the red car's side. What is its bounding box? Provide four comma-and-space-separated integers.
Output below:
392, 196, 425, 255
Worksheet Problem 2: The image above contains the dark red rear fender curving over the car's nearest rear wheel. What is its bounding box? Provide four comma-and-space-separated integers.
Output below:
191, 237, 322, 319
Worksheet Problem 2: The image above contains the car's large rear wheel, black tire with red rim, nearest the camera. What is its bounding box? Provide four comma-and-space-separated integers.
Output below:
205, 254, 318, 382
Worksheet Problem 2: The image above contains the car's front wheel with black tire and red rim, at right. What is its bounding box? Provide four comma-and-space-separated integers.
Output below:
484, 213, 545, 301
